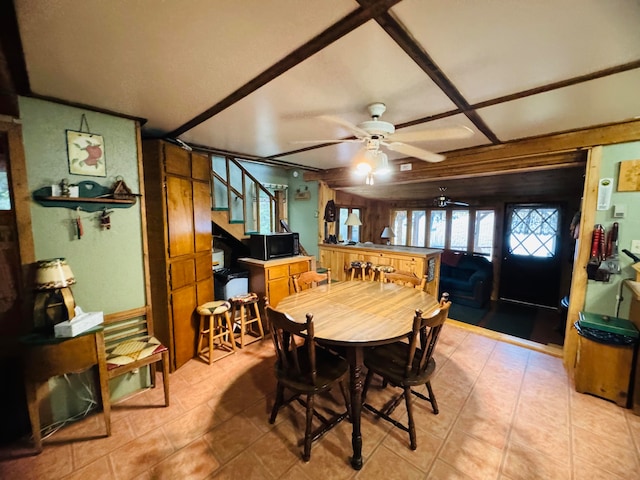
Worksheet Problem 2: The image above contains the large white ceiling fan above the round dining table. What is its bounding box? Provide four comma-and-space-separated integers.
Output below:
296, 102, 473, 163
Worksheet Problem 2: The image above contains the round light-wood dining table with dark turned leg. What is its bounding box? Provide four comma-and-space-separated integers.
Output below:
275, 281, 438, 470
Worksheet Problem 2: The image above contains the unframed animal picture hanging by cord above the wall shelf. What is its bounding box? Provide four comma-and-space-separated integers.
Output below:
67, 113, 107, 177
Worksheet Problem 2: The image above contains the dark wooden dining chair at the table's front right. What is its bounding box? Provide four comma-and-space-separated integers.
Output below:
362, 293, 451, 450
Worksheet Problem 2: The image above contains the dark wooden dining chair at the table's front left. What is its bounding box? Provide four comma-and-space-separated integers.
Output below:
265, 305, 349, 461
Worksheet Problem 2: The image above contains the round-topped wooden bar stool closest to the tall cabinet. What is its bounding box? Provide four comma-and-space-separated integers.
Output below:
197, 300, 236, 365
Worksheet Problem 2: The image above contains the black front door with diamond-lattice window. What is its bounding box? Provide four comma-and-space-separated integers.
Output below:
500, 204, 562, 308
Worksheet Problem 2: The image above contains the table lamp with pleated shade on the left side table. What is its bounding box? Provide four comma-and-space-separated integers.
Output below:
33, 258, 76, 334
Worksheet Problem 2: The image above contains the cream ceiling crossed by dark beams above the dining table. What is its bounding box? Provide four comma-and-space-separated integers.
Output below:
14, 0, 640, 176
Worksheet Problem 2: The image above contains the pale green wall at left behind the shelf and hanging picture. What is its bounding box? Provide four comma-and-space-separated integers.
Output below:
19, 97, 148, 424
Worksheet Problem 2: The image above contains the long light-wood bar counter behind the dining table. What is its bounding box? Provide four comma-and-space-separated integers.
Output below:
318, 243, 442, 297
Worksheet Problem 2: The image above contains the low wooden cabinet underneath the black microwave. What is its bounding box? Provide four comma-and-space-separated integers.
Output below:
238, 255, 315, 307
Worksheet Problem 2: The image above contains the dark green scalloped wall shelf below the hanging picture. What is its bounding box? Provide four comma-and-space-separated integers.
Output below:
33, 180, 136, 212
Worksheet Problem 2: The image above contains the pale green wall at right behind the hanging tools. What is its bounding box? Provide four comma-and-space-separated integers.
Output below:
580, 142, 640, 318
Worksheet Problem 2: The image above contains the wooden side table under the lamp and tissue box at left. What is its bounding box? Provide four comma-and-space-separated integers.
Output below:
20, 326, 111, 452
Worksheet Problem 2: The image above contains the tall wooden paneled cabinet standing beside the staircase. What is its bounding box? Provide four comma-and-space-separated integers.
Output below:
143, 140, 213, 371
